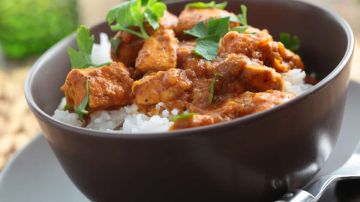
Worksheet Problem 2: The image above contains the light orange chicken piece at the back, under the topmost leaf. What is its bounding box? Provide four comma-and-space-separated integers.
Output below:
175, 8, 237, 35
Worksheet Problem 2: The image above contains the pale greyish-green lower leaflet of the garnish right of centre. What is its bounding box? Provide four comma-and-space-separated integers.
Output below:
194, 36, 219, 60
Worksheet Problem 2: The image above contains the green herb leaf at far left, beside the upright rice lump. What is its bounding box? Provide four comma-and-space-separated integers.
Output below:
67, 25, 94, 68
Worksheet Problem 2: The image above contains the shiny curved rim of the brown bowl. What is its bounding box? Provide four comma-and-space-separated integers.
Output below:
24, 0, 355, 139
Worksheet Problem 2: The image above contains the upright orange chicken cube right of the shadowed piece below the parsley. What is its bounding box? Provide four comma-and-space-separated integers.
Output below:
135, 29, 178, 72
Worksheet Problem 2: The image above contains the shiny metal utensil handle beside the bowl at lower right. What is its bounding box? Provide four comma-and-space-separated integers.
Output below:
276, 145, 360, 202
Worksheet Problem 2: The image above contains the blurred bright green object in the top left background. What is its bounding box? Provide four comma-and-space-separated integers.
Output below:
0, 0, 79, 58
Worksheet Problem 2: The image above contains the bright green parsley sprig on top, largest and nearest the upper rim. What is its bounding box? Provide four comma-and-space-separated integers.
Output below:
106, 0, 166, 39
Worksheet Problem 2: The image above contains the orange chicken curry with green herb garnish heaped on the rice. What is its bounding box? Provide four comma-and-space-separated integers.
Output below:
61, 0, 312, 130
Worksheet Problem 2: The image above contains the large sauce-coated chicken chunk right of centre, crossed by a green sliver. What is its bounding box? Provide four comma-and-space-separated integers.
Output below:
190, 54, 284, 111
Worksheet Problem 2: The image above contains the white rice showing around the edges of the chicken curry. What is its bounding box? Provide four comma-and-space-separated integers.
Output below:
53, 33, 312, 134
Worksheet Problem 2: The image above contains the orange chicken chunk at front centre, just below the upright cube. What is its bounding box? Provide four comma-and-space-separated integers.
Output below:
132, 69, 192, 105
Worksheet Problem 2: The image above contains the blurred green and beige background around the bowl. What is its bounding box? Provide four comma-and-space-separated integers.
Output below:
0, 0, 360, 170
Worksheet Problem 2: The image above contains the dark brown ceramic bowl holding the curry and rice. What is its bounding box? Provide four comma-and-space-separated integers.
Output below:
25, 0, 354, 202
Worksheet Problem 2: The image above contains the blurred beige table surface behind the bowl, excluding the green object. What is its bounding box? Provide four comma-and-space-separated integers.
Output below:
0, 0, 360, 170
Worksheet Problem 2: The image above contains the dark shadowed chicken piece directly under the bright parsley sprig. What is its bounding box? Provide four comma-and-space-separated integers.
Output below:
111, 31, 144, 67
